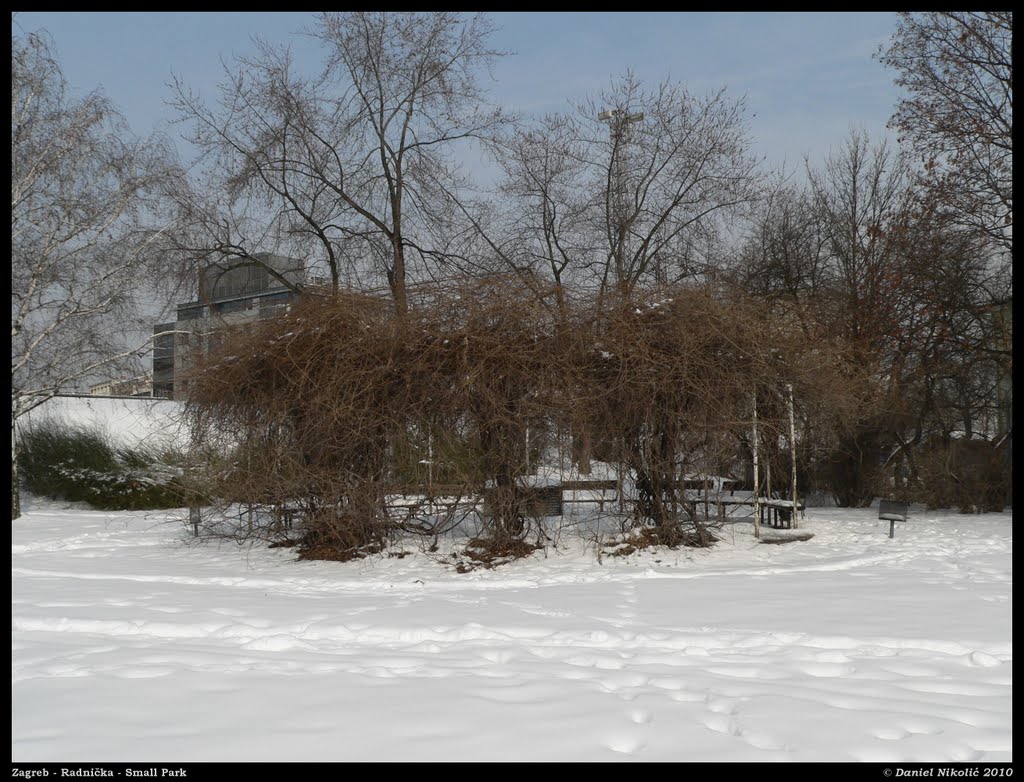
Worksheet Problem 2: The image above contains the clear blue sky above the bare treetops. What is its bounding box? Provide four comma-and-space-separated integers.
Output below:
15, 12, 899, 175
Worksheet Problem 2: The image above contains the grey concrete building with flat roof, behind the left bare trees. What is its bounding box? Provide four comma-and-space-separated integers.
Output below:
153, 253, 305, 399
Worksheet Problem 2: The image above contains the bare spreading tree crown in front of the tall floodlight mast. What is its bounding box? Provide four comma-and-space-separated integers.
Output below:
580, 73, 757, 295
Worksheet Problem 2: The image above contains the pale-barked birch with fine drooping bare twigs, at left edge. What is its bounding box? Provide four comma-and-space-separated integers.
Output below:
11, 24, 174, 518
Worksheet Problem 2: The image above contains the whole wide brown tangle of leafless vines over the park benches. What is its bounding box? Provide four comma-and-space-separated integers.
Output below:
187, 278, 847, 559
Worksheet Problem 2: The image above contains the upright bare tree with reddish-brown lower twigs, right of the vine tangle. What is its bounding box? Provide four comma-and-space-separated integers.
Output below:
774, 131, 915, 506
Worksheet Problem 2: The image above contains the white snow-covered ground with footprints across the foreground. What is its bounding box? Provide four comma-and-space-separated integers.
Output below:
11, 498, 1013, 763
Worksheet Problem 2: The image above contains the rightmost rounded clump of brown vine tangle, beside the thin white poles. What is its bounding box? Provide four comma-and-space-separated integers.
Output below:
578, 289, 856, 546
